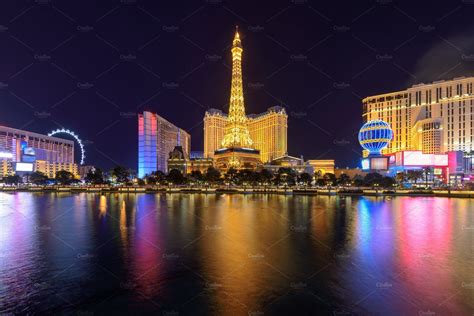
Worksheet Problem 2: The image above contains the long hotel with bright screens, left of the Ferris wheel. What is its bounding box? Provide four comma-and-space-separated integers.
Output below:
0, 126, 77, 178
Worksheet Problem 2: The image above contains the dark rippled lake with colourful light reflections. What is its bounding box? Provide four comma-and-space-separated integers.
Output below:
0, 193, 474, 316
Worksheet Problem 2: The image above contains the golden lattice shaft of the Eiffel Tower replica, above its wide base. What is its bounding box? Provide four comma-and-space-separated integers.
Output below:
222, 26, 253, 148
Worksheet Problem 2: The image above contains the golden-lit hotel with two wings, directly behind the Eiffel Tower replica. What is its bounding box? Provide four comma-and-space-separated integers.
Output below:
204, 106, 288, 163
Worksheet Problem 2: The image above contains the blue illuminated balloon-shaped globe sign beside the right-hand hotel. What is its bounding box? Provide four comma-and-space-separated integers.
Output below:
359, 120, 393, 156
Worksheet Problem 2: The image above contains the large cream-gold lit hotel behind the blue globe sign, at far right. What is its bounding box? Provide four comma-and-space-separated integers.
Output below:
362, 77, 474, 156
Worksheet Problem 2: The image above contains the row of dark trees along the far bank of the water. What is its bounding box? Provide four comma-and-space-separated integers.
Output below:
1, 166, 434, 188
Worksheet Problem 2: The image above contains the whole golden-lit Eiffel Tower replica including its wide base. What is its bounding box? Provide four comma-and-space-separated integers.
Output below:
214, 29, 262, 171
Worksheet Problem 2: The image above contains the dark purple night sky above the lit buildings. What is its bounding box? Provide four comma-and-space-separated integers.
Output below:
0, 0, 474, 169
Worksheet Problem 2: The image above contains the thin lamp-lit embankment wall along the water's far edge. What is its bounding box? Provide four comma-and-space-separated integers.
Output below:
0, 186, 474, 198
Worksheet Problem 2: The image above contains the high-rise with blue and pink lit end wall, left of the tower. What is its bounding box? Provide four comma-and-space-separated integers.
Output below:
138, 111, 191, 178
